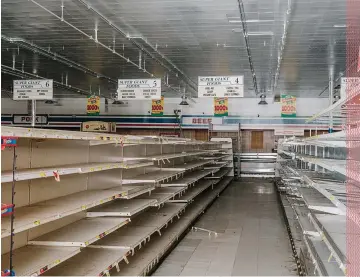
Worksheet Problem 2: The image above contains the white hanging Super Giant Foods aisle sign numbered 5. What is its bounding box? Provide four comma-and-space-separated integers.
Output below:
117, 79, 161, 100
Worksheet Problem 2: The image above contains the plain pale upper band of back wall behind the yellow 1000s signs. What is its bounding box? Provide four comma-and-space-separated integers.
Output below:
1, 98, 329, 117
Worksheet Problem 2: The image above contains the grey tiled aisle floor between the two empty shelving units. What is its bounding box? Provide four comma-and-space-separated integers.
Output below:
153, 179, 297, 276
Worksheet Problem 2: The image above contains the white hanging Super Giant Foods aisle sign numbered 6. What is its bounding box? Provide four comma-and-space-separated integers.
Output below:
13, 79, 53, 100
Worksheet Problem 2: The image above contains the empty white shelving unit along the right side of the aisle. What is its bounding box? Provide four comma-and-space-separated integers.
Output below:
279, 127, 360, 275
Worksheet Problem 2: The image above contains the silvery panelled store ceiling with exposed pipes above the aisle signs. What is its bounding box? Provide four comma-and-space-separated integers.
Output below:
1, 0, 352, 97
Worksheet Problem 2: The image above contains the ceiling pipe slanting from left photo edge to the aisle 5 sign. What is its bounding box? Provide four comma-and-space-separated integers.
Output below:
1, 35, 117, 84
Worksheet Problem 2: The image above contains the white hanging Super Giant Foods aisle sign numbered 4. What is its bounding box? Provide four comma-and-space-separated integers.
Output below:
198, 76, 244, 97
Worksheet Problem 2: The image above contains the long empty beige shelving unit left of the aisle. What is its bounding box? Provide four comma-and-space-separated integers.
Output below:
1, 127, 232, 276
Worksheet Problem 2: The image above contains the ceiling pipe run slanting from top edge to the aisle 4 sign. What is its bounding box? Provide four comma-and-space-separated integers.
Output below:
78, 0, 197, 91
